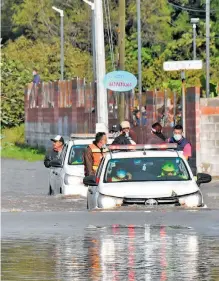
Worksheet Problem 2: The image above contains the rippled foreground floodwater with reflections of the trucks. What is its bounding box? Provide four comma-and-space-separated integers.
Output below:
2, 225, 219, 281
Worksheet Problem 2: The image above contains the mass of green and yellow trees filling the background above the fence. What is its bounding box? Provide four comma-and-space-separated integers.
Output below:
2, 0, 219, 127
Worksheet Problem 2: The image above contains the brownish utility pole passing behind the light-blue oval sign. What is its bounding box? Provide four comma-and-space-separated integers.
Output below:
119, 0, 125, 122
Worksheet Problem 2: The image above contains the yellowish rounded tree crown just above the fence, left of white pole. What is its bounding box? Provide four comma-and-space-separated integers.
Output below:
3, 36, 92, 81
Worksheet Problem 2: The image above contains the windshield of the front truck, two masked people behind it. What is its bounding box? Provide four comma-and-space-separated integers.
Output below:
104, 157, 191, 183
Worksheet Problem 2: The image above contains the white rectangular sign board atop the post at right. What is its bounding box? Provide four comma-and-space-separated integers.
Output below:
163, 60, 202, 71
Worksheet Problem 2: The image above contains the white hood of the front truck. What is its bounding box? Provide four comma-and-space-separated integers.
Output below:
99, 180, 199, 198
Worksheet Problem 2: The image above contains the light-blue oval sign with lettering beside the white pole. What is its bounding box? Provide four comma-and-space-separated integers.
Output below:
103, 71, 137, 92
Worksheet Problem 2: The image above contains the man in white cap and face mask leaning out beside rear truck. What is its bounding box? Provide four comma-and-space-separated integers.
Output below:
44, 135, 65, 168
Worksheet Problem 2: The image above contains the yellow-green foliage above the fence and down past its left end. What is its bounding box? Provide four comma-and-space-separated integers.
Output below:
1, 37, 92, 127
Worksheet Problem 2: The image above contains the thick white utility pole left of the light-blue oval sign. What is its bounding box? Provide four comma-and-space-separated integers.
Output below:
94, 0, 108, 132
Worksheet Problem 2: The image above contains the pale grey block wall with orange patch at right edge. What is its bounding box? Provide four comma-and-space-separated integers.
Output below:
198, 98, 219, 176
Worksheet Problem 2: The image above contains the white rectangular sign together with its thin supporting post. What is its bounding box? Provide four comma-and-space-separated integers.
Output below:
163, 60, 202, 135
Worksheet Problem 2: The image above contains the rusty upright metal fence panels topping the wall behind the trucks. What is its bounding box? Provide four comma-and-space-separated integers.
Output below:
26, 78, 182, 132
